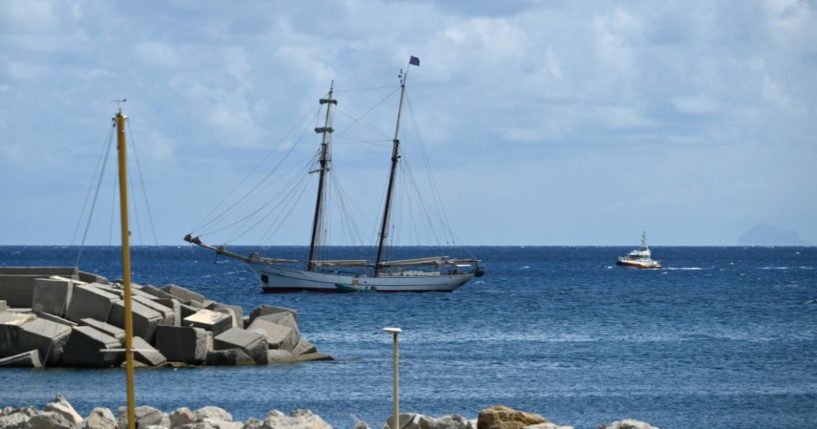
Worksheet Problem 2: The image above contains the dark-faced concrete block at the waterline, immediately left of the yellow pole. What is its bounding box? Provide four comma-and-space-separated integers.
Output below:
62, 326, 125, 367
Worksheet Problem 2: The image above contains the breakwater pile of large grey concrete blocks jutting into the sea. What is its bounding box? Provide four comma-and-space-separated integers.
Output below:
0, 267, 332, 368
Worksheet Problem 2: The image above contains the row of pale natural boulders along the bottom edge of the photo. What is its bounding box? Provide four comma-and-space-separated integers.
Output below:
0, 394, 658, 429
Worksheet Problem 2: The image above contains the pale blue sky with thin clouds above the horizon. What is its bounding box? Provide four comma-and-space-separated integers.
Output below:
0, 0, 817, 245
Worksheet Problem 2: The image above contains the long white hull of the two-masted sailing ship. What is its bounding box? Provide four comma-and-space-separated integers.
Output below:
249, 263, 474, 292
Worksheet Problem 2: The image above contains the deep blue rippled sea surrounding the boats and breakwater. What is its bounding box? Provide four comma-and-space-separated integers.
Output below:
0, 246, 817, 428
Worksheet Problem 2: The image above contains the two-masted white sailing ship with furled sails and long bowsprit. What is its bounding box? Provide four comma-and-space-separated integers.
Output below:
184, 56, 484, 292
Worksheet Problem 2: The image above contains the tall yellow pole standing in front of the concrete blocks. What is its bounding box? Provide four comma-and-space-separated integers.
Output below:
116, 108, 136, 429
